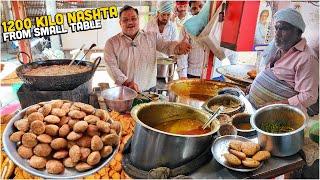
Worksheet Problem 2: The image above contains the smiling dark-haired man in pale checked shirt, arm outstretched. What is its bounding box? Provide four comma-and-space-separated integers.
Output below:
104, 5, 191, 91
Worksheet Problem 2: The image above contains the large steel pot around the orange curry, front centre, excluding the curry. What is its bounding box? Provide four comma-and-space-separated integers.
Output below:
130, 102, 220, 170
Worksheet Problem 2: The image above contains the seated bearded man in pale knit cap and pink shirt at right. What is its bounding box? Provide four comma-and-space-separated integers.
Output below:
248, 8, 319, 113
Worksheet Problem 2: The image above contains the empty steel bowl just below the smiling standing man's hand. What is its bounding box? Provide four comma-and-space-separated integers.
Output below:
101, 86, 138, 112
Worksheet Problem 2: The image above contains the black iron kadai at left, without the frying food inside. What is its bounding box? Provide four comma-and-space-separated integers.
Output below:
16, 52, 101, 91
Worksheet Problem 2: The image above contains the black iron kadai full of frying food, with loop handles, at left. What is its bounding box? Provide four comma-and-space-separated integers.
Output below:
16, 52, 101, 91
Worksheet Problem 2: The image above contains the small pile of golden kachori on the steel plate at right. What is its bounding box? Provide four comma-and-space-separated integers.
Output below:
224, 140, 271, 168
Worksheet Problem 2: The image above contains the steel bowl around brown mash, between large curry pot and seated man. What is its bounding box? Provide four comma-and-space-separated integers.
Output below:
202, 94, 244, 116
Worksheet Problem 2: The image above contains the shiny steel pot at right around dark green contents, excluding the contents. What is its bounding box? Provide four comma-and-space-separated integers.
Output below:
250, 104, 306, 157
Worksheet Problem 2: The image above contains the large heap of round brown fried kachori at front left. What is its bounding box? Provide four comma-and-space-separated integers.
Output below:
9, 100, 121, 174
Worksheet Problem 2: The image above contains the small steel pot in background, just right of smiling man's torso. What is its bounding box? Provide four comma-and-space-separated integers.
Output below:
157, 58, 174, 78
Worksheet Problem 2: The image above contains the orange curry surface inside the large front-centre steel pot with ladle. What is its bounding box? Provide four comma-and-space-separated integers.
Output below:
154, 119, 211, 135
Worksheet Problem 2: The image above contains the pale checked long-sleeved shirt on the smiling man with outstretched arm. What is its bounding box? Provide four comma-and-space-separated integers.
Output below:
104, 31, 178, 91
